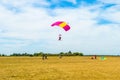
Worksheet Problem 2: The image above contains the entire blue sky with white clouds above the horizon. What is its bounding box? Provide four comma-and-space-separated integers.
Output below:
0, 0, 120, 55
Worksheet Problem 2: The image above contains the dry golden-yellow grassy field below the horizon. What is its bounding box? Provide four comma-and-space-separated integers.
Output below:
0, 57, 120, 80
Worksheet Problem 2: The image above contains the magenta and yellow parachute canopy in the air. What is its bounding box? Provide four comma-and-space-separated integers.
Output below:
51, 21, 70, 31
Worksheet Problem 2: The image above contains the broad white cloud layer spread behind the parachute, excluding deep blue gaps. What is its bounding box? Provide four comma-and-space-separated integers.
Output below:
0, 0, 120, 54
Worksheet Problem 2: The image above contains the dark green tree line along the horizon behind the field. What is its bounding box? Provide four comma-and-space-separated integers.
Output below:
0, 51, 83, 57
